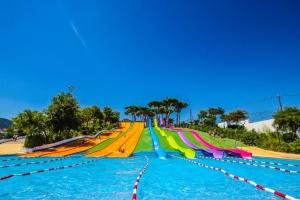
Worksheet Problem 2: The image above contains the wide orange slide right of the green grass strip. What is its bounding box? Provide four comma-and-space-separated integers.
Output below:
86, 122, 144, 157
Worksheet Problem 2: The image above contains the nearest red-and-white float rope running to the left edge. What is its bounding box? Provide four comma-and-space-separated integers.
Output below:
0, 159, 99, 181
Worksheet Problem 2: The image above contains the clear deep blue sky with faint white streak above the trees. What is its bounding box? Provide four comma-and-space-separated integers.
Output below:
0, 0, 300, 119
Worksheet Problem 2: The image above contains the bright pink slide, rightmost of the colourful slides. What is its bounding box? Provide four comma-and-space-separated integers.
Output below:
190, 131, 252, 158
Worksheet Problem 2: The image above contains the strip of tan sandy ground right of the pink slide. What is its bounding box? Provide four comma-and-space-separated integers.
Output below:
241, 147, 300, 160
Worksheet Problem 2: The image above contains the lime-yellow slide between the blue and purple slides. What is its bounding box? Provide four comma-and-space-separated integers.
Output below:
154, 119, 196, 158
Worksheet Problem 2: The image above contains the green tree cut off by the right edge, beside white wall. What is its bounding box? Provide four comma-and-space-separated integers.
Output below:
273, 107, 300, 141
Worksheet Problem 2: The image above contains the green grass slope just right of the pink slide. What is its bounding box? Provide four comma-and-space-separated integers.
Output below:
184, 129, 245, 148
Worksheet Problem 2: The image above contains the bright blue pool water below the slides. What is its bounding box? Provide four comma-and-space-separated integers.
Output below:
0, 154, 300, 200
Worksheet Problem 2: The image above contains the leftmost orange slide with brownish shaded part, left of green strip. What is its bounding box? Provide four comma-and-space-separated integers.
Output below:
22, 122, 130, 157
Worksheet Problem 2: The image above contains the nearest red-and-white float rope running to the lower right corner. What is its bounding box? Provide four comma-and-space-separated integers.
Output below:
173, 156, 299, 200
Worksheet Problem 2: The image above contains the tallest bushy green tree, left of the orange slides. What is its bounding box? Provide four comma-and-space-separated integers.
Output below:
46, 92, 80, 139
